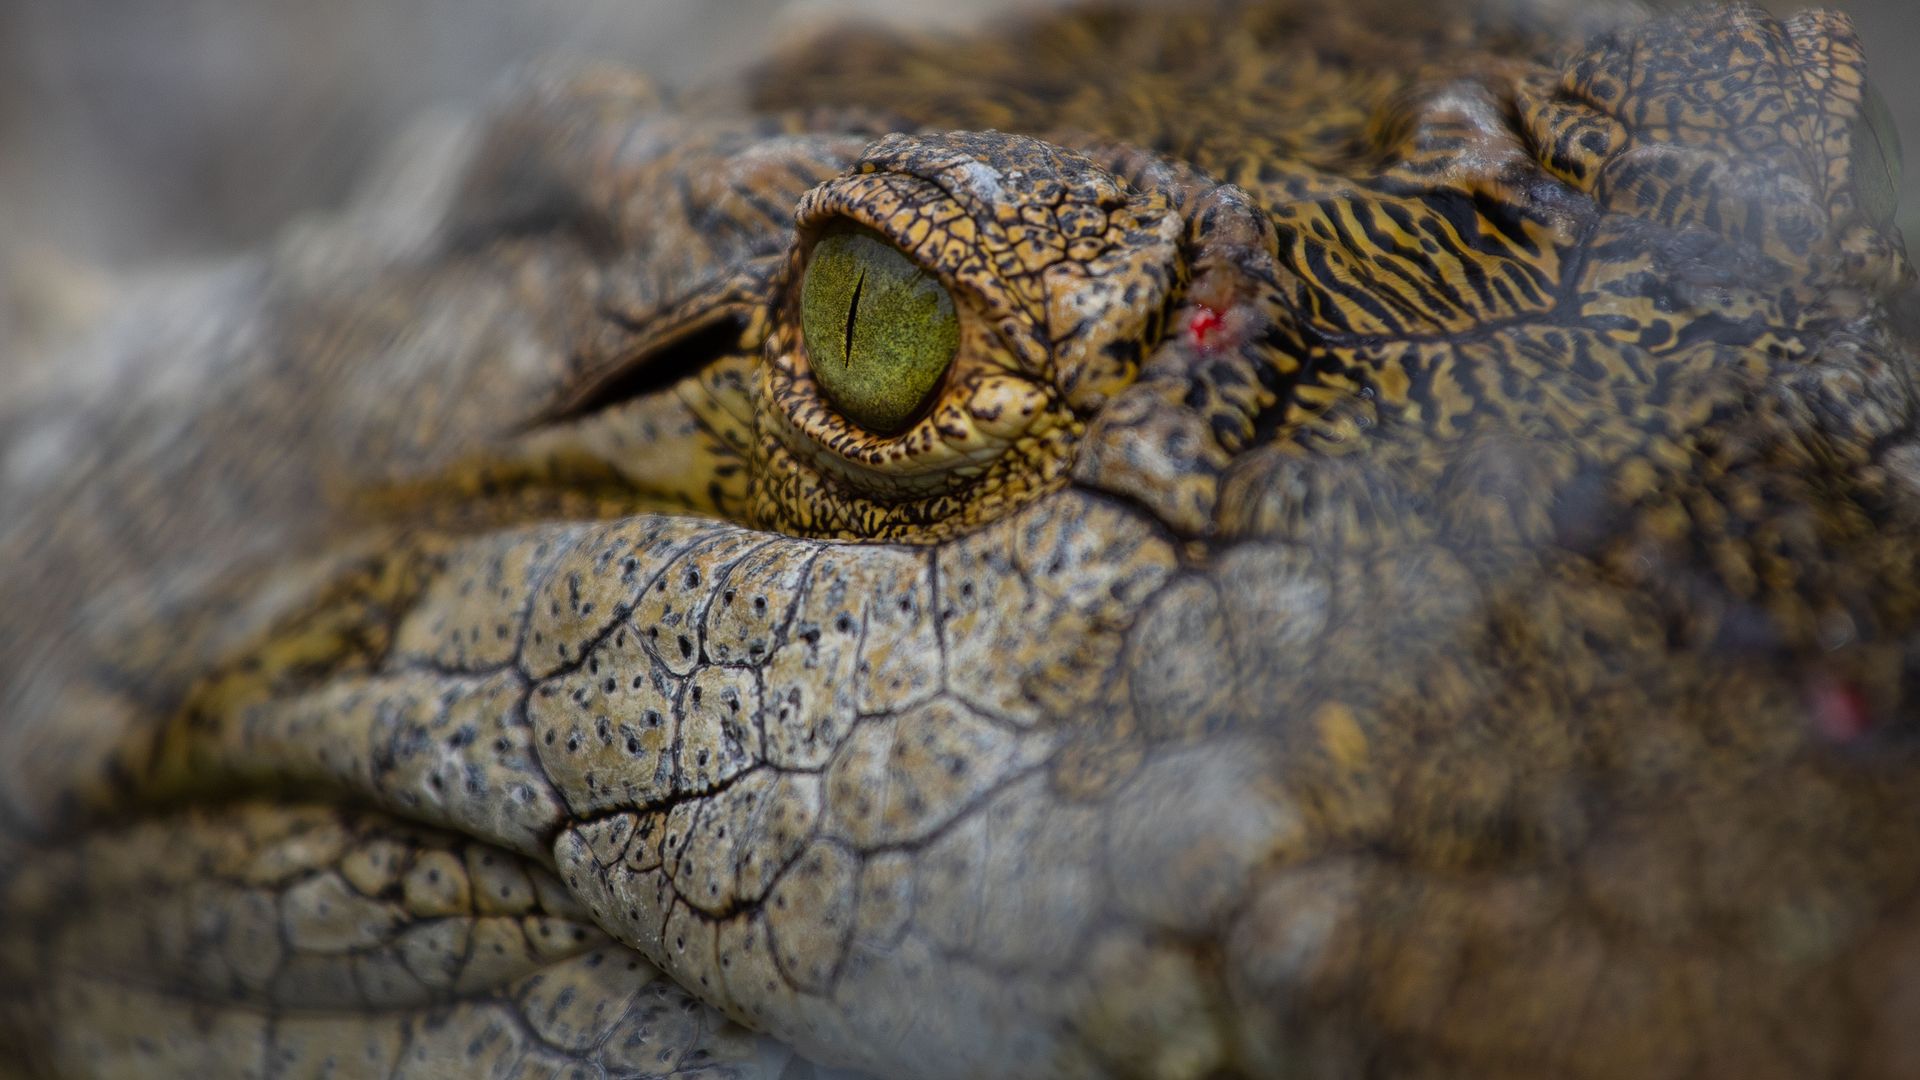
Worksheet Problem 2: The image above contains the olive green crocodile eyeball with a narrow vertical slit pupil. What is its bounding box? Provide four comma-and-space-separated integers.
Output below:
801, 231, 960, 434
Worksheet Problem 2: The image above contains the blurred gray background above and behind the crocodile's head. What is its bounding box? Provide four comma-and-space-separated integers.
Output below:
0, 0, 1920, 273
